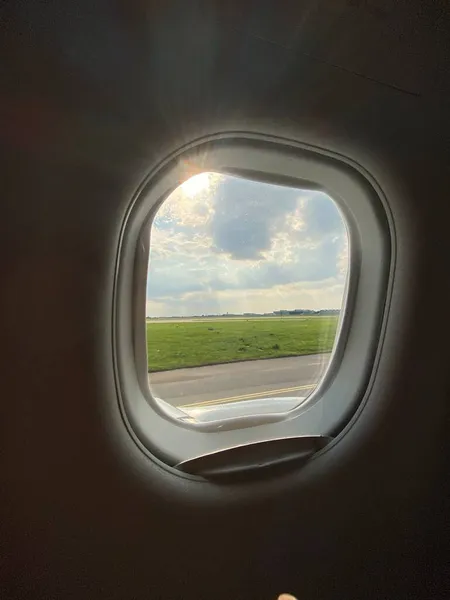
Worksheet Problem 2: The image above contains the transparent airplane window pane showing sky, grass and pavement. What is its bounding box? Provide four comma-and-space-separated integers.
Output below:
146, 172, 349, 422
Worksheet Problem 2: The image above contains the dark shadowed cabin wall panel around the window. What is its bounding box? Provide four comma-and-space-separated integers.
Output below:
0, 0, 450, 600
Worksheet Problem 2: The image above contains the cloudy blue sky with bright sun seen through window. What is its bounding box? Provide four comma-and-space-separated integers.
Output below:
146, 173, 348, 317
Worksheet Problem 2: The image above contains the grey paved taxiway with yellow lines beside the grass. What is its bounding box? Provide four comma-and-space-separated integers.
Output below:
149, 354, 330, 406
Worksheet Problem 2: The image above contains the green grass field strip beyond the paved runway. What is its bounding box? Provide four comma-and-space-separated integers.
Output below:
147, 316, 338, 372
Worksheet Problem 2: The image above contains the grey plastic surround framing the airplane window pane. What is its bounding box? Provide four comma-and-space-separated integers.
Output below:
113, 134, 392, 466
